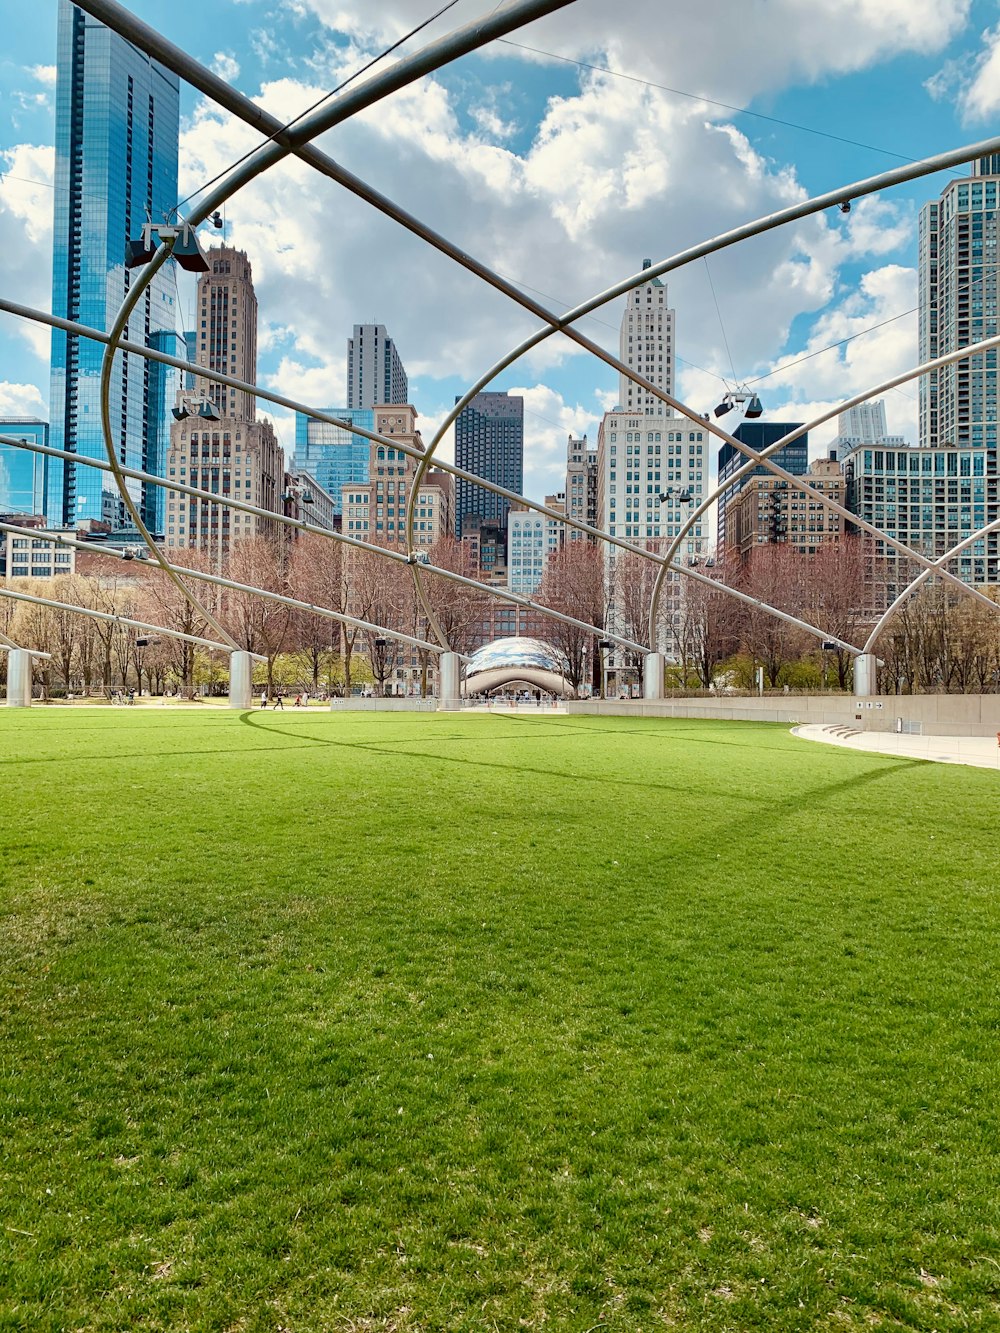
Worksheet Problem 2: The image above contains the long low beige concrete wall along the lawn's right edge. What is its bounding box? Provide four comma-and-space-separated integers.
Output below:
565, 694, 1000, 736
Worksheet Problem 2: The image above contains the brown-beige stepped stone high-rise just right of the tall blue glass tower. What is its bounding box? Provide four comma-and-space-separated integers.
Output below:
164, 245, 284, 565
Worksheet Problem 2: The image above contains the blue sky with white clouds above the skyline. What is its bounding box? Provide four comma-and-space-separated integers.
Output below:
0, 0, 1000, 497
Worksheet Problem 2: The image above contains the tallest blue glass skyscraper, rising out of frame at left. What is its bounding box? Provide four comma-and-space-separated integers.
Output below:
47, 0, 184, 528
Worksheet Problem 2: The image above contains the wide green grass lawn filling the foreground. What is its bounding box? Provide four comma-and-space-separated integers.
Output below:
0, 708, 1000, 1333
